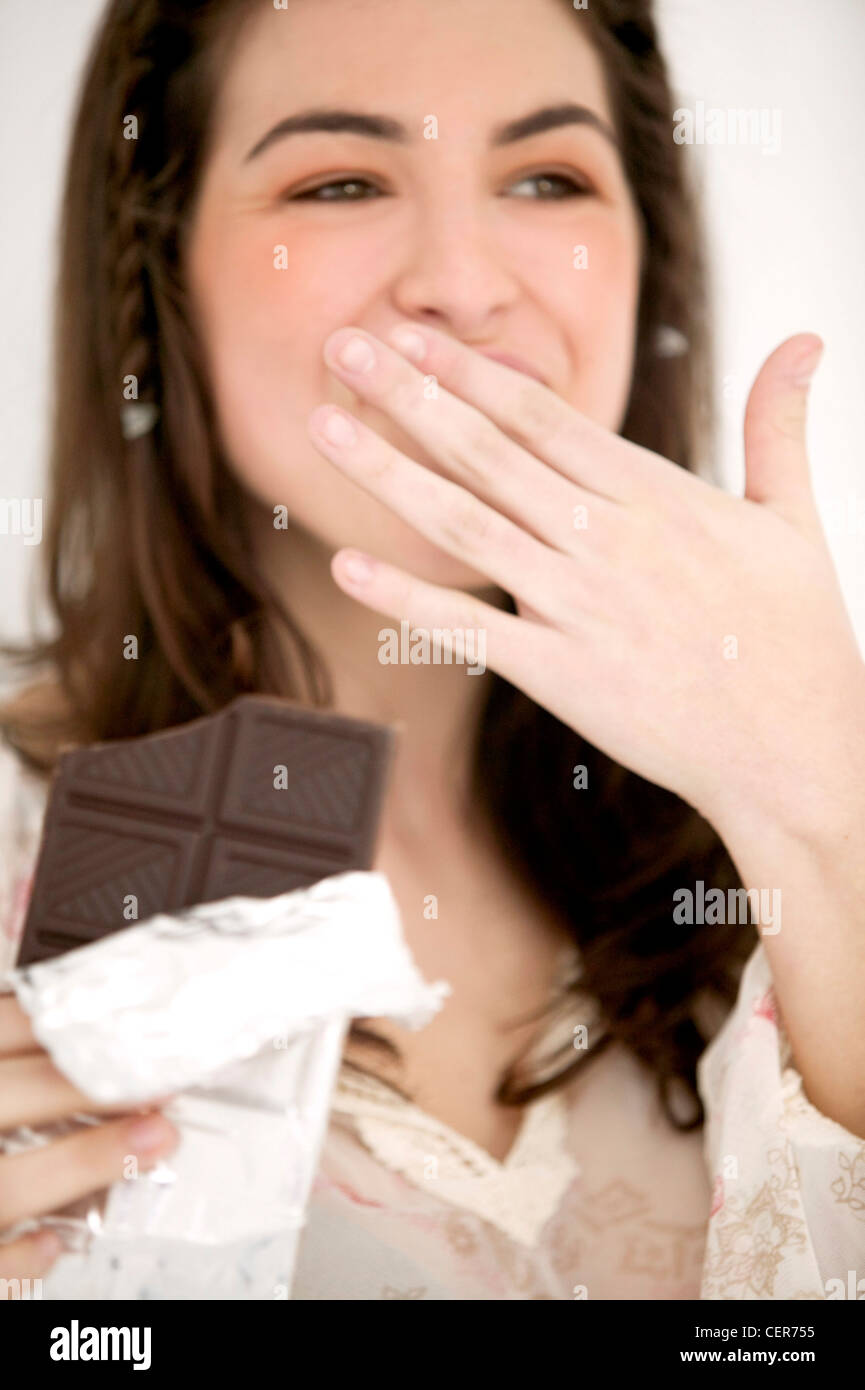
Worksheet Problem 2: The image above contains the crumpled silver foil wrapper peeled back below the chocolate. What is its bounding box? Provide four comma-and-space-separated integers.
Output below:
0, 870, 449, 1298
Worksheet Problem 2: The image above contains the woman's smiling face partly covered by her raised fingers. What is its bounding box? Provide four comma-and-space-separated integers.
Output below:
186, 0, 640, 588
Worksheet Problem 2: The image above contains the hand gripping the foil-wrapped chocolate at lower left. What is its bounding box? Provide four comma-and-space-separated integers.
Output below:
0, 995, 179, 1280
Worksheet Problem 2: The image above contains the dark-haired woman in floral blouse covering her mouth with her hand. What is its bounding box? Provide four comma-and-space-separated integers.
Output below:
0, 0, 865, 1298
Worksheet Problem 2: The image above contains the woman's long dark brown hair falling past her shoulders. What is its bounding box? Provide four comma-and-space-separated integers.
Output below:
0, 0, 752, 1129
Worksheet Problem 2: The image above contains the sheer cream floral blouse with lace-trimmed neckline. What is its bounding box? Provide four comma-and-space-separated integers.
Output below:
0, 745, 865, 1300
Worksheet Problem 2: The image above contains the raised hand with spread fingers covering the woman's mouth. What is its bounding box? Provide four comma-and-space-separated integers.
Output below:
309, 325, 865, 824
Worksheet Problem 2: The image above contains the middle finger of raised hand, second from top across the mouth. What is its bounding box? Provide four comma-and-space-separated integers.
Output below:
319, 329, 615, 550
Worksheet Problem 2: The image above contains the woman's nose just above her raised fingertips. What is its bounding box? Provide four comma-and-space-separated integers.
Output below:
392, 199, 519, 338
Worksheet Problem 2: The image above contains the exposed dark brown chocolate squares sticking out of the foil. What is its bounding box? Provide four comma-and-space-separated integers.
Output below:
18, 695, 394, 966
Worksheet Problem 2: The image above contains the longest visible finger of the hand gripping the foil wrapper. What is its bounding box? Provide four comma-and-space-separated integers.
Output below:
0, 1111, 179, 1230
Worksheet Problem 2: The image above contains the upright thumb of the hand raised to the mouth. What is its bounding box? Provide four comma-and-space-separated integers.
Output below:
745, 334, 823, 521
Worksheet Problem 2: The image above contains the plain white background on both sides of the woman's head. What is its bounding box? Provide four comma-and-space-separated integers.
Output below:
0, 0, 865, 661
